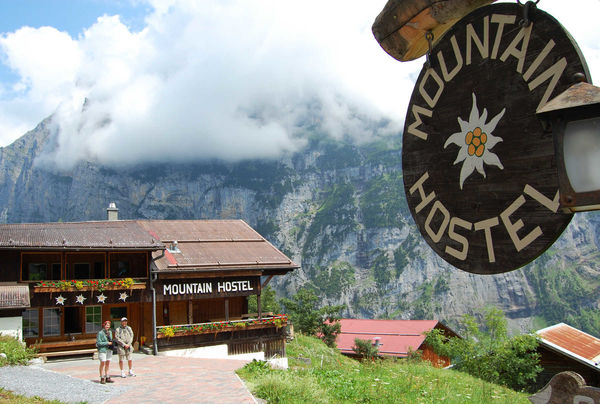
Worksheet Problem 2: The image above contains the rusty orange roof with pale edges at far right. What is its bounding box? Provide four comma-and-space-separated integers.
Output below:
536, 323, 600, 370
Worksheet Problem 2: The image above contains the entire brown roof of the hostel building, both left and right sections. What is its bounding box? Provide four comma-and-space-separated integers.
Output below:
0, 220, 298, 275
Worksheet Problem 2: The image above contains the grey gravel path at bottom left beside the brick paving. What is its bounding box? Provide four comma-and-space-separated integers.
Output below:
0, 365, 130, 404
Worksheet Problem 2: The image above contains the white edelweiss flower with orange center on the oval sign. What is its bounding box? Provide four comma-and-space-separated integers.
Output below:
444, 93, 506, 189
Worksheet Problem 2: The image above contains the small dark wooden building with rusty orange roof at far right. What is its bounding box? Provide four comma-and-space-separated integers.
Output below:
536, 323, 600, 388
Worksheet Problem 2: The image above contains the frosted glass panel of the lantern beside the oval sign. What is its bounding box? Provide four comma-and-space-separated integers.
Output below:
563, 117, 600, 193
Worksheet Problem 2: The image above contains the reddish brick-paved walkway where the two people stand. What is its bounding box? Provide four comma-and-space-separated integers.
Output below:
43, 354, 256, 404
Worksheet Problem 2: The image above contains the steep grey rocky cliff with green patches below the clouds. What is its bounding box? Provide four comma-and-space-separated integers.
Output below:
0, 119, 600, 335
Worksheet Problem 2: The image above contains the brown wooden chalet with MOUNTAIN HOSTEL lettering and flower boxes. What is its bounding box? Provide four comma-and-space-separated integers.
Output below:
0, 204, 298, 356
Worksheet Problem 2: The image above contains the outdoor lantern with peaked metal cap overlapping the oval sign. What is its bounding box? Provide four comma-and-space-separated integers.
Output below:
536, 74, 600, 212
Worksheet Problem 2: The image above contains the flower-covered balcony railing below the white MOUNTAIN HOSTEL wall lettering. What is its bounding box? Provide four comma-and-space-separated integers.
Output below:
156, 315, 287, 338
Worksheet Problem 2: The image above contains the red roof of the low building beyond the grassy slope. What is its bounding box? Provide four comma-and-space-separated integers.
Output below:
336, 319, 456, 357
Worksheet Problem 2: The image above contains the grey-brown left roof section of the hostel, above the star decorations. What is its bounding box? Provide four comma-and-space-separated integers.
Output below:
0, 220, 164, 250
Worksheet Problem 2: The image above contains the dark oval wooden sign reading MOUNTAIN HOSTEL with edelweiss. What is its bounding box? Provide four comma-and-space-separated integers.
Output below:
402, 4, 589, 274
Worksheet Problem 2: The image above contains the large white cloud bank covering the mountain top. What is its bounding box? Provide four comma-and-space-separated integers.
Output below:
0, 0, 600, 168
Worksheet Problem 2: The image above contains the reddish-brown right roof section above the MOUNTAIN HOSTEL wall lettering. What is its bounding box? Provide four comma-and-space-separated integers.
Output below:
139, 220, 298, 272
